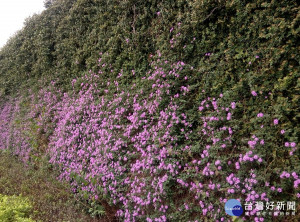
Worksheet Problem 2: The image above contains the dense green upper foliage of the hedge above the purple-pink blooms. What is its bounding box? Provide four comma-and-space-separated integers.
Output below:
0, 0, 300, 137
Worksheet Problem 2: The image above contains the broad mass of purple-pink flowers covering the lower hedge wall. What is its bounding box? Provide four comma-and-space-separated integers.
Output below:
0, 49, 300, 222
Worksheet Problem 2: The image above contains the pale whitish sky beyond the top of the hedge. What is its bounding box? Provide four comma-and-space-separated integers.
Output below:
0, 0, 44, 48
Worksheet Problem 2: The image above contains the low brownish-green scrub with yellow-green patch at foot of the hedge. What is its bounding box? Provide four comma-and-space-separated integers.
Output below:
0, 152, 113, 222
